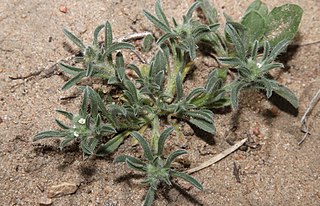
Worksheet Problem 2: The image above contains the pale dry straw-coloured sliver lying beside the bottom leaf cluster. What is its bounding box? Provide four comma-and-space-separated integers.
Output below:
187, 138, 248, 174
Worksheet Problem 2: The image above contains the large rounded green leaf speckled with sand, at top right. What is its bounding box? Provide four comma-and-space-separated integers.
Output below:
266, 4, 303, 47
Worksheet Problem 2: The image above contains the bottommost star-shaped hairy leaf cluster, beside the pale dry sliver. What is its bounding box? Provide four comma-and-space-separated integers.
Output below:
114, 127, 203, 206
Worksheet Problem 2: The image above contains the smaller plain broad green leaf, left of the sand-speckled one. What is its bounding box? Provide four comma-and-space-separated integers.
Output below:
241, 10, 266, 49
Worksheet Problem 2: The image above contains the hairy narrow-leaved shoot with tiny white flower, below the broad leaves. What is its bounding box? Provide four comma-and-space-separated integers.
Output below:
218, 24, 298, 109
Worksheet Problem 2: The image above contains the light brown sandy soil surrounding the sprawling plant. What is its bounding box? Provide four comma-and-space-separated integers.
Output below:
0, 0, 320, 206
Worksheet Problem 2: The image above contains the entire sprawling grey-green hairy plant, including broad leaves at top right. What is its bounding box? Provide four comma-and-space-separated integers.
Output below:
34, 0, 302, 205
